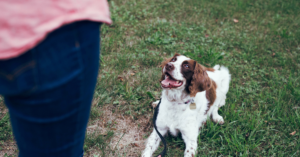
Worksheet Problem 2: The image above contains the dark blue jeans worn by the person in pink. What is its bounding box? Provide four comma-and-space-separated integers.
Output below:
0, 21, 101, 157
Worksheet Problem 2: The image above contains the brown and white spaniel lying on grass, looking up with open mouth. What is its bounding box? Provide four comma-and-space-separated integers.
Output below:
142, 53, 231, 157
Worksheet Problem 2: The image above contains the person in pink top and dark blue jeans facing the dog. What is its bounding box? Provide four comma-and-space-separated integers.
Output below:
0, 0, 112, 157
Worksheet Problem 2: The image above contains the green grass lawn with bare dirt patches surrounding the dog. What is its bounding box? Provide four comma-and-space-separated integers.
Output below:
0, 0, 300, 157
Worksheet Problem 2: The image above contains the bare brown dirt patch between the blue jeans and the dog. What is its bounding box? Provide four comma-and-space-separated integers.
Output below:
84, 106, 152, 157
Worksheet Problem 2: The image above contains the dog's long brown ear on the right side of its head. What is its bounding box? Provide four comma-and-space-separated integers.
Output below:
189, 62, 211, 97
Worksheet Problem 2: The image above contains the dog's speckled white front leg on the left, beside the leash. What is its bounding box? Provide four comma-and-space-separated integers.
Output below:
142, 128, 167, 157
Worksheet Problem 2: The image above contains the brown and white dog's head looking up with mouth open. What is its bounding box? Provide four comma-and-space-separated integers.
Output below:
161, 53, 211, 97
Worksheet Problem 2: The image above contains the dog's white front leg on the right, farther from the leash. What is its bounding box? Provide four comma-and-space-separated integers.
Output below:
181, 127, 198, 157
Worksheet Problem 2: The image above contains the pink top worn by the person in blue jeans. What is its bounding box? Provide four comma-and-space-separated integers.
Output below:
0, 0, 112, 60
